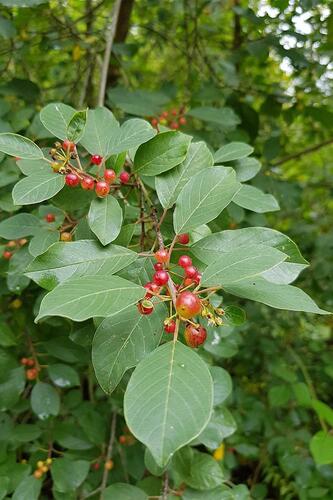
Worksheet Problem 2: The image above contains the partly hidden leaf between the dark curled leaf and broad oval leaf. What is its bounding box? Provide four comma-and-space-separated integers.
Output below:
155, 142, 213, 208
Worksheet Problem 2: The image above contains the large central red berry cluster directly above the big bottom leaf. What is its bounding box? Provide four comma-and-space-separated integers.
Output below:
138, 234, 224, 347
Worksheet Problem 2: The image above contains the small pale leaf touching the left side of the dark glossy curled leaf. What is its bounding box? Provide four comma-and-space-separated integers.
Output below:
108, 118, 156, 155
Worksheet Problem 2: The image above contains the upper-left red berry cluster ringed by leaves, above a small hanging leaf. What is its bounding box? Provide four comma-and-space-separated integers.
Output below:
50, 139, 130, 198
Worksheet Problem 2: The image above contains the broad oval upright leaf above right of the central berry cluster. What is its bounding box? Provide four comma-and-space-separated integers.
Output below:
173, 167, 240, 234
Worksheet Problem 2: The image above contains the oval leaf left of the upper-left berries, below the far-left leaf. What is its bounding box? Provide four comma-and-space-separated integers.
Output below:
12, 171, 65, 205
